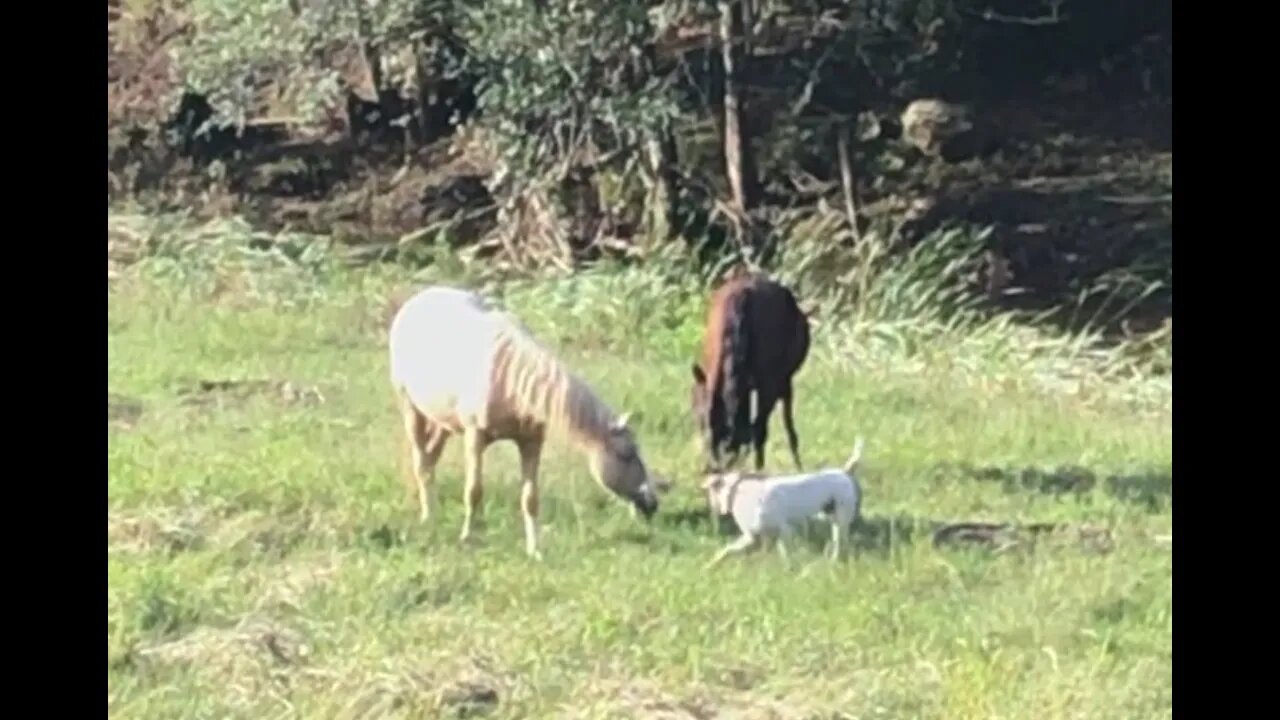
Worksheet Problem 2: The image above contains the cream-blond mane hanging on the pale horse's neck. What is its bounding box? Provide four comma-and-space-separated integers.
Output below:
493, 315, 616, 445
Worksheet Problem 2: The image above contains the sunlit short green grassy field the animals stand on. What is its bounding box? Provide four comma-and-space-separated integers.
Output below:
108, 226, 1172, 720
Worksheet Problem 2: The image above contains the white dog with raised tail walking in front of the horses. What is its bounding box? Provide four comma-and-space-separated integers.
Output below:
703, 438, 863, 568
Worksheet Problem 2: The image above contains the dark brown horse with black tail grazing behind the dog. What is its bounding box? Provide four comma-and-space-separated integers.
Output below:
690, 274, 809, 470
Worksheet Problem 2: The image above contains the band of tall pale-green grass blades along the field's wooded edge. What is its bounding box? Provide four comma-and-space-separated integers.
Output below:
109, 207, 1172, 406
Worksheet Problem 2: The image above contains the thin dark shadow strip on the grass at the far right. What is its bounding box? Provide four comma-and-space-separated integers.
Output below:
938, 464, 1174, 511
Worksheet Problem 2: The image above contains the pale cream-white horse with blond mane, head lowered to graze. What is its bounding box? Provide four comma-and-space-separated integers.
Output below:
389, 287, 668, 559
